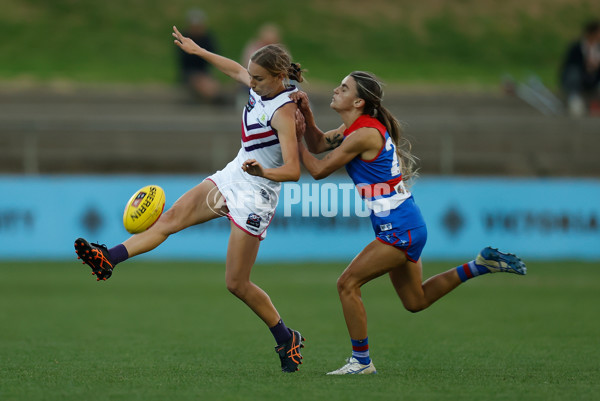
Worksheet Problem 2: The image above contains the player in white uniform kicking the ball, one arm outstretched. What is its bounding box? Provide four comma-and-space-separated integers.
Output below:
75, 27, 303, 372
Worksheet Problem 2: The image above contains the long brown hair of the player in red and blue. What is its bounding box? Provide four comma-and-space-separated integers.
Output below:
350, 71, 418, 181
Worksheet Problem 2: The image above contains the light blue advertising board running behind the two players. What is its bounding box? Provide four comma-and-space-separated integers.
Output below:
0, 175, 600, 261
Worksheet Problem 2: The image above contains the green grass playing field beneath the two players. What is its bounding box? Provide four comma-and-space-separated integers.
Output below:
0, 261, 600, 401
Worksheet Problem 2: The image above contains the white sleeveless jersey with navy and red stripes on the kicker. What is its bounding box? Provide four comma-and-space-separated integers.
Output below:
238, 86, 298, 168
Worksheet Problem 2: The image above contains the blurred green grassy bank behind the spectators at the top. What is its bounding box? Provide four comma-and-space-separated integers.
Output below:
0, 0, 600, 88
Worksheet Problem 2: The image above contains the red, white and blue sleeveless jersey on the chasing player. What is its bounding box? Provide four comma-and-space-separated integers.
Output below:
344, 115, 425, 233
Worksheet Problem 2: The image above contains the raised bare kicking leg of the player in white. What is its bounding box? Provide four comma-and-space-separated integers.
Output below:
123, 180, 227, 257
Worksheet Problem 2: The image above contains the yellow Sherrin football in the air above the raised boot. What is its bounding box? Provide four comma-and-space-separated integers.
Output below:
123, 185, 165, 234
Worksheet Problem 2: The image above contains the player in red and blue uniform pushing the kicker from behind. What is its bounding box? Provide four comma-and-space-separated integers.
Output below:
291, 71, 527, 375
